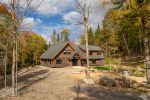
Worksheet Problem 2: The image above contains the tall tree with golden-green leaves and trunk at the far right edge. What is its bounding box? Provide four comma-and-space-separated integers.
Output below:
102, 0, 150, 83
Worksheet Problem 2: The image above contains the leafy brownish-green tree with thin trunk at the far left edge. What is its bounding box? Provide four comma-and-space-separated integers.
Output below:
0, 4, 14, 87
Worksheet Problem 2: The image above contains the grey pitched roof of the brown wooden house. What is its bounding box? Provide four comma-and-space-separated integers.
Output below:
40, 42, 102, 59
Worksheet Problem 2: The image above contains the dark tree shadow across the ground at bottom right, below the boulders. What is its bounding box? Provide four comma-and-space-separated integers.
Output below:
71, 86, 150, 100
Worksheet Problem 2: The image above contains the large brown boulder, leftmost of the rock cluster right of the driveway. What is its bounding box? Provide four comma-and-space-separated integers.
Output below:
100, 76, 115, 87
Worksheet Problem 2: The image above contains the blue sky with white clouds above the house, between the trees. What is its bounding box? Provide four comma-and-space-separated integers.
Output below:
0, 0, 108, 41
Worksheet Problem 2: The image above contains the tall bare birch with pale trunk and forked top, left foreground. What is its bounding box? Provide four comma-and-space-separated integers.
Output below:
2, 0, 44, 95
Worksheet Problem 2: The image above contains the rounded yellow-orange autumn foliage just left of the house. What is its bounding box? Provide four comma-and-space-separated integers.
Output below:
18, 31, 47, 69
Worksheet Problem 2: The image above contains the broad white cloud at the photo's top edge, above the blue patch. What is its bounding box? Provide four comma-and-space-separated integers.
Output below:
33, 0, 74, 15
